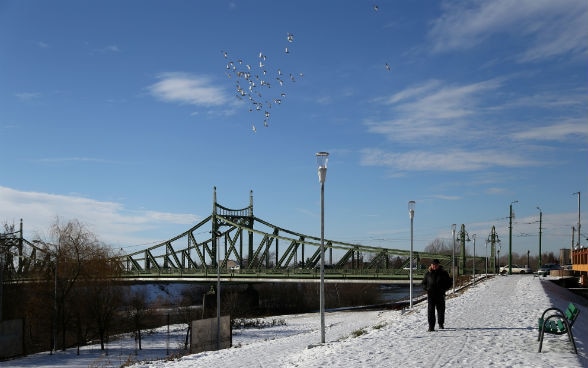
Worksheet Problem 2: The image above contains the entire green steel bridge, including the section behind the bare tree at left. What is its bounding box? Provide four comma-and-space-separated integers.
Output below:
0, 188, 486, 283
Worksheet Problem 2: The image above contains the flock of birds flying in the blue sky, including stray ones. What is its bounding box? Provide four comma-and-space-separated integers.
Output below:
221, 5, 390, 133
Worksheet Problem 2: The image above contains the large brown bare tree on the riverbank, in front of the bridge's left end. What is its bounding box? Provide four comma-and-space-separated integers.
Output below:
39, 219, 120, 350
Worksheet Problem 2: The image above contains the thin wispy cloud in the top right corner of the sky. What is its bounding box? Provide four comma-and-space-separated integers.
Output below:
429, 0, 588, 62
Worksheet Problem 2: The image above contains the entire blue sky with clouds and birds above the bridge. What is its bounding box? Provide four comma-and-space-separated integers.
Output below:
0, 0, 588, 254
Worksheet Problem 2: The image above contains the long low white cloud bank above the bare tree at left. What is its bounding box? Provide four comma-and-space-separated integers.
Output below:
0, 186, 200, 245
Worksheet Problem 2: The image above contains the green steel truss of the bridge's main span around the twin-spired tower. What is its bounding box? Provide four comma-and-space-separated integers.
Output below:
119, 188, 450, 277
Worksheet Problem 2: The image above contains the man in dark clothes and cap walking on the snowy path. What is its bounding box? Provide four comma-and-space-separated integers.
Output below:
422, 259, 453, 332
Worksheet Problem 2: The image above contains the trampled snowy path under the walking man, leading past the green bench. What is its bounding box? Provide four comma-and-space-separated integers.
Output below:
288, 275, 588, 367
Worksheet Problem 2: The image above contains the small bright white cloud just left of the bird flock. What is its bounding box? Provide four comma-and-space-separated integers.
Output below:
148, 72, 226, 106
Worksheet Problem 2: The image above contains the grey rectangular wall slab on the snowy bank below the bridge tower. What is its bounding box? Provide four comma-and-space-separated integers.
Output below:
190, 316, 233, 354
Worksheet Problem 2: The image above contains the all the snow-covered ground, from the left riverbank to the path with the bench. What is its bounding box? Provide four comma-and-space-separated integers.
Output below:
0, 275, 588, 368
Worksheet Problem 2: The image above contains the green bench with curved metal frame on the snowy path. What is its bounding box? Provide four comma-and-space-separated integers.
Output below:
537, 303, 580, 354
